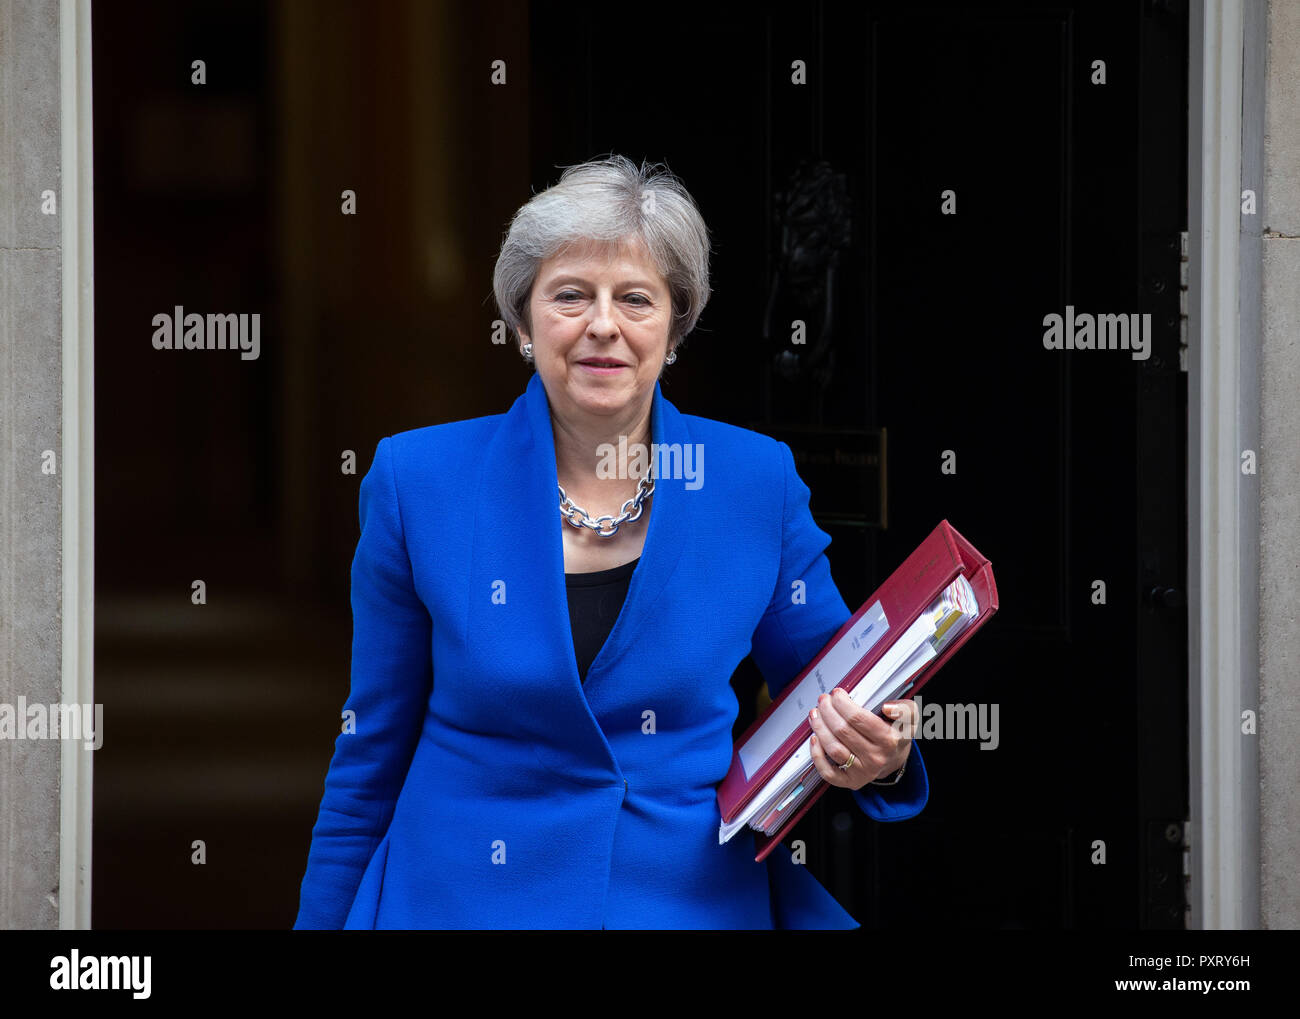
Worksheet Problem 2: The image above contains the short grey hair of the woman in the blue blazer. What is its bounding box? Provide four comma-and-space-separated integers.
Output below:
493, 153, 711, 348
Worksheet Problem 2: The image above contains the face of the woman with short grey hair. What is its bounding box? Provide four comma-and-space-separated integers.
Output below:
520, 235, 672, 425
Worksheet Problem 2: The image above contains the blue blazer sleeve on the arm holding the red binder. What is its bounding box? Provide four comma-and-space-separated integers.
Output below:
751, 442, 930, 821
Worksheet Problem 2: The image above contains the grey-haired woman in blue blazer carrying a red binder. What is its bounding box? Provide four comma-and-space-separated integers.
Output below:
295, 156, 928, 928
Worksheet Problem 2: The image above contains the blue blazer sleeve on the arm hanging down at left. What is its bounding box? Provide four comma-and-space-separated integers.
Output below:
294, 437, 433, 931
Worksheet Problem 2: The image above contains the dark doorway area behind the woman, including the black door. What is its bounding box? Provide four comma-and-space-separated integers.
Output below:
92, 0, 1187, 928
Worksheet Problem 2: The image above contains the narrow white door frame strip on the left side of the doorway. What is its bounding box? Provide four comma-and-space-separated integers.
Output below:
59, 0, 95, 931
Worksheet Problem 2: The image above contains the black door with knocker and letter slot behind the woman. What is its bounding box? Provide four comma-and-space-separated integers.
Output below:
529, 0, 1188, 928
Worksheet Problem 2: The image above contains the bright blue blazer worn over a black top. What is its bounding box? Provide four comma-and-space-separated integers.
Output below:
294, 374, 930, 929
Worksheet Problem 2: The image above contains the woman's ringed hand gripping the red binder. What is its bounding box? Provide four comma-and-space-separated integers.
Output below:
809, 686, 914, 789
